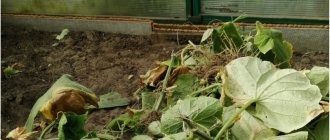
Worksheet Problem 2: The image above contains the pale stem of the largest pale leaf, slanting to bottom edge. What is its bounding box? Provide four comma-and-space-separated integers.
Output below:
215, 99, 258, 140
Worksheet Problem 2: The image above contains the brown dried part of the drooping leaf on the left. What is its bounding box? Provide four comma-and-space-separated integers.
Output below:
40, 89, 98, 120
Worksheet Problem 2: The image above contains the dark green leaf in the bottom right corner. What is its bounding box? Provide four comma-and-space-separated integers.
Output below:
313, 116, 329, 140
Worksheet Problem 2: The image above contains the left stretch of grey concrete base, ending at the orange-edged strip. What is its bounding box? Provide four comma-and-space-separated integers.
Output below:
1, 15, 152, 35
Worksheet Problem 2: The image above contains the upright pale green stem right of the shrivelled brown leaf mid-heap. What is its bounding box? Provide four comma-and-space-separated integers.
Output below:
153, 52, 175, 111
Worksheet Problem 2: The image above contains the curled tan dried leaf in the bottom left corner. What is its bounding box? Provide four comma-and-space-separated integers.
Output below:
6, 127, 38, 140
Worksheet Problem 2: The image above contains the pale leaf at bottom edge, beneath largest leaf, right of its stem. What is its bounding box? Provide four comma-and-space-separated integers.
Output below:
231, 109, 277, 140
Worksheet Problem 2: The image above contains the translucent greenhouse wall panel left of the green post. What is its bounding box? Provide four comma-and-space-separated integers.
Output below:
1, 0, 187, 18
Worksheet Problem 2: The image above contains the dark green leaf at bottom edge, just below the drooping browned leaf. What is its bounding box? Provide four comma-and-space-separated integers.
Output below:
58, 113, 87, 140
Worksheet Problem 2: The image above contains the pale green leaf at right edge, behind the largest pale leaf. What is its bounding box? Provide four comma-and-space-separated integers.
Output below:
306, 66, 329, 97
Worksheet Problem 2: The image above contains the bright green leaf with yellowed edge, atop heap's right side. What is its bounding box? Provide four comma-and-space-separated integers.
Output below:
254, 21, 293, 68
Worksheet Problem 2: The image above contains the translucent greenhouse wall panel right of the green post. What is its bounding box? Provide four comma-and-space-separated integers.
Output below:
201, 0, 329, 20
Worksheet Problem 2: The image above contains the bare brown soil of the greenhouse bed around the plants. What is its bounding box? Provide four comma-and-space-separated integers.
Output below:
1, 26, 329, 139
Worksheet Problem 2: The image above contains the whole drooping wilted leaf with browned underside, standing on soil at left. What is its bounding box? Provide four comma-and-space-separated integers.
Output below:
25, 74, 97, 132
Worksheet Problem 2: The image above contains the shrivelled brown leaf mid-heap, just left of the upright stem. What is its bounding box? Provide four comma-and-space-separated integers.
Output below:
140, 65, 167, 87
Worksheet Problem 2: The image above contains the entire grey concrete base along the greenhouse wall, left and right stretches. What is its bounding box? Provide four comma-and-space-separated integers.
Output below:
1, 15, 329, 52
